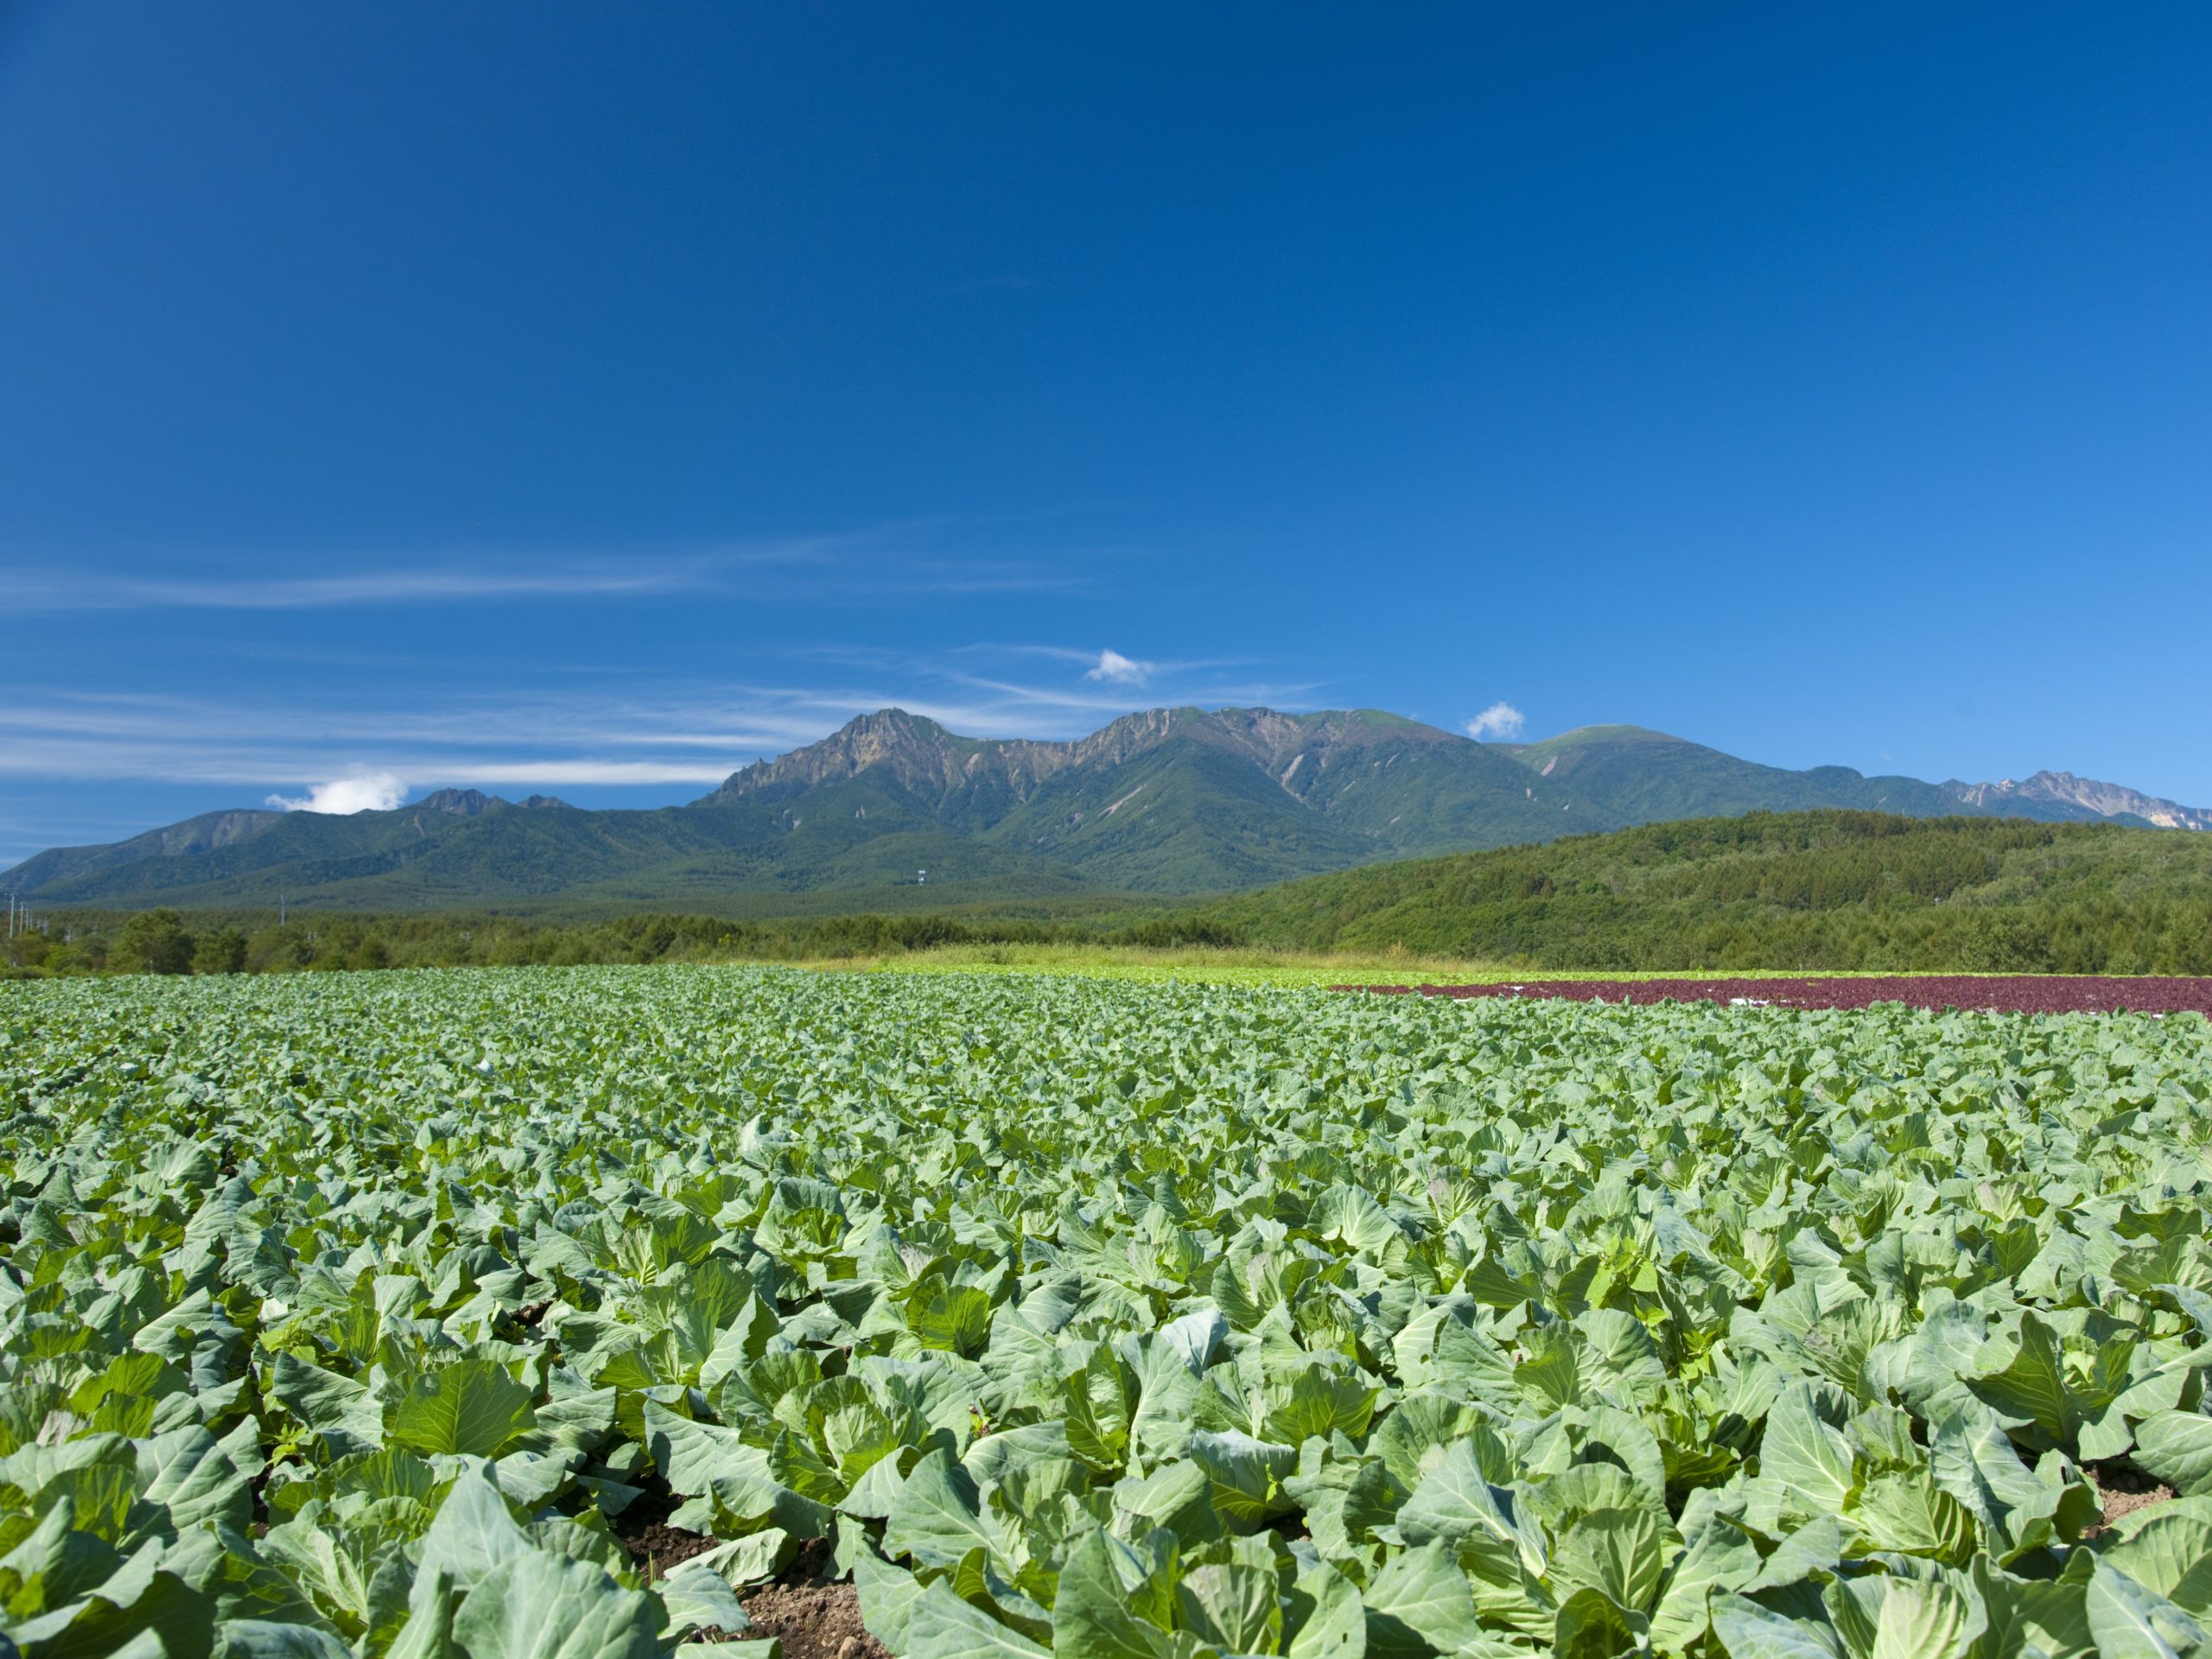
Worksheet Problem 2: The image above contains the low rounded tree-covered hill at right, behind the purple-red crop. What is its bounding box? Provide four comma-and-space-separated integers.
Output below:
1205, 812, 2212, 973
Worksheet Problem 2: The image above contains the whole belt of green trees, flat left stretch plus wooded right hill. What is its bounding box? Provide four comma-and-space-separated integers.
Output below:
17, 812, 2212, 976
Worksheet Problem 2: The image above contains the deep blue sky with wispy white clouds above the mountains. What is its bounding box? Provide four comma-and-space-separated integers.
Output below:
0, 0, 2212, 862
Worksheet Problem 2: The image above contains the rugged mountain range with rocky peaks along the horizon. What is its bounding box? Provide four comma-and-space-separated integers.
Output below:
0, 708, 2212, 913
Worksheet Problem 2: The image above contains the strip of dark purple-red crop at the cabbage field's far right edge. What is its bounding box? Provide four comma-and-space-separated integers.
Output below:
1330, 973, 2212, 1013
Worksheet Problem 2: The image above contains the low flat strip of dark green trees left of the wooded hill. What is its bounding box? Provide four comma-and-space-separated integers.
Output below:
4, 909, 1232, 978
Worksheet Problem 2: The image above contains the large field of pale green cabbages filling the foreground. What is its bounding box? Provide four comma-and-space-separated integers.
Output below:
0, 967, 2212, 1659
